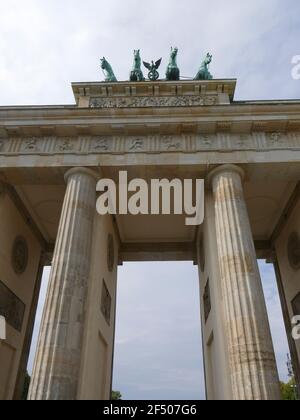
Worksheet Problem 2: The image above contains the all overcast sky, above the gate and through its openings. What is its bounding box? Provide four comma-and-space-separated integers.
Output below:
0, 0, 300, 399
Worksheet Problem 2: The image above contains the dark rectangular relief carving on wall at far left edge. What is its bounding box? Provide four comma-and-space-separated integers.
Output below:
0, 281, 26, 332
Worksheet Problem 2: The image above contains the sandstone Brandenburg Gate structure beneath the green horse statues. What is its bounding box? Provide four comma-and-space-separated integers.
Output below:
0, 63, 300, 400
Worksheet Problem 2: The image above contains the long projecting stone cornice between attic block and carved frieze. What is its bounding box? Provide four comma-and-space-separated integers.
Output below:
0, 103, 300, 138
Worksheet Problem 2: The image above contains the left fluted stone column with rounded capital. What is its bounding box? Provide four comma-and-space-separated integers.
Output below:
29, 168, 97, 400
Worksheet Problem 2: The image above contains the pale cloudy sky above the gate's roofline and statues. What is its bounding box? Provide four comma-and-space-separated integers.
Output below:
0, 0, 300, 105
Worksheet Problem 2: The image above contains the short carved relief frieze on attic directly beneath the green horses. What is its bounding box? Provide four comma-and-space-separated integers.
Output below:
90, 95, 218, 108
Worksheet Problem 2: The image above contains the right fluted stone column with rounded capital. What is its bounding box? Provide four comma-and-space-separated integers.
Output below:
209, 165, 281, 400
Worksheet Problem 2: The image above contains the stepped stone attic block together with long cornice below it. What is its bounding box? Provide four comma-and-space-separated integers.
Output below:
0, 79, 300, 138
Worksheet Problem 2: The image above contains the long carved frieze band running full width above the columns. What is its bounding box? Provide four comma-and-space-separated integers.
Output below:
0, 133, 300, 156
